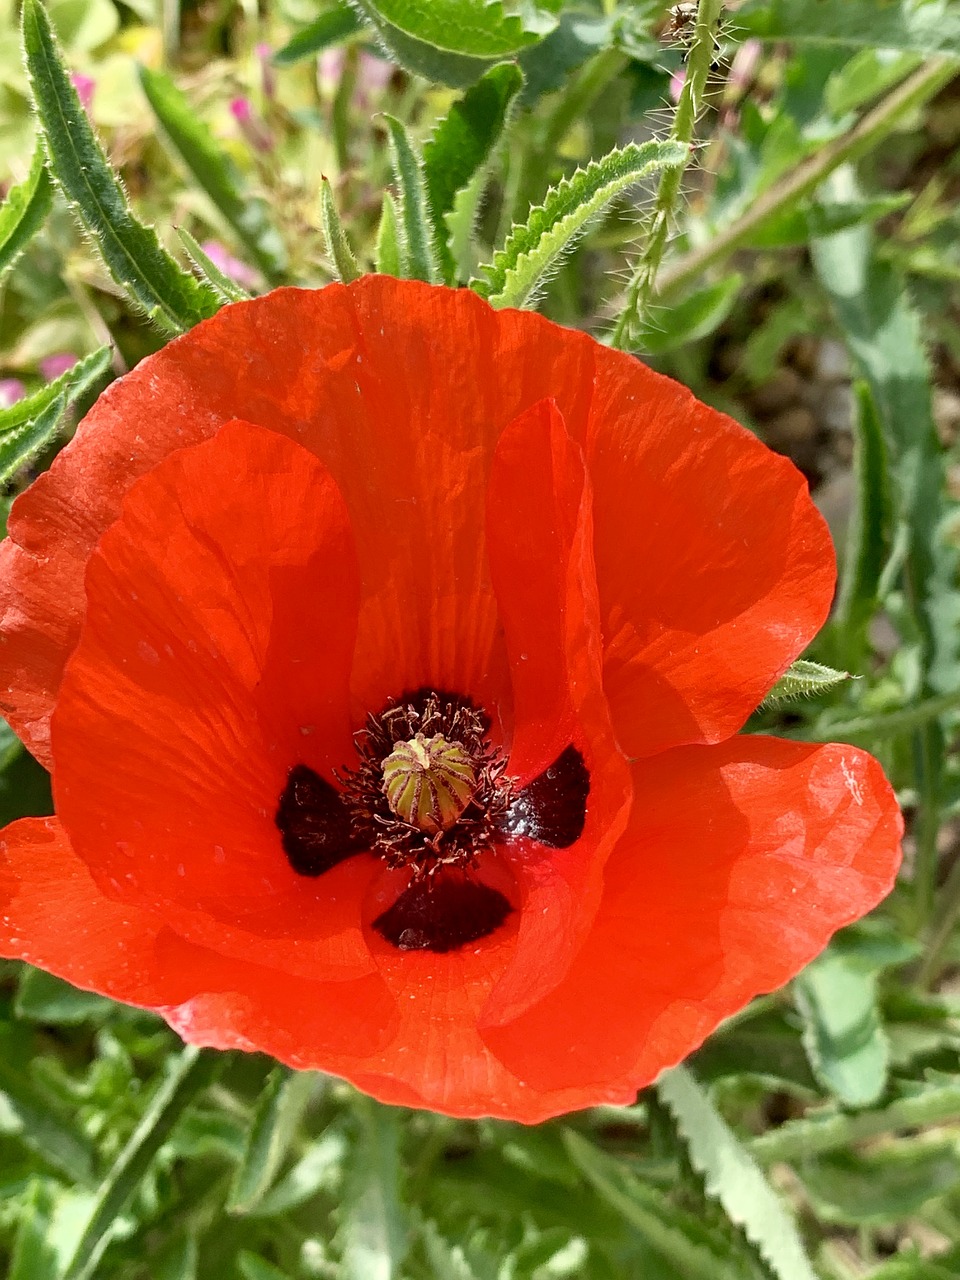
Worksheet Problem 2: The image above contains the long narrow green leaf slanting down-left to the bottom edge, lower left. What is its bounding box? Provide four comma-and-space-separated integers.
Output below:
63, 1046, 225, 1280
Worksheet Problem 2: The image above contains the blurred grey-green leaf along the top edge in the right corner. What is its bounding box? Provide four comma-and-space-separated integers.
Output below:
735, 0, 960, 58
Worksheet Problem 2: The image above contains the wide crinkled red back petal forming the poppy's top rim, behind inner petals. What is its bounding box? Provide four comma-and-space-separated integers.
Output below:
0, 275, 833, 762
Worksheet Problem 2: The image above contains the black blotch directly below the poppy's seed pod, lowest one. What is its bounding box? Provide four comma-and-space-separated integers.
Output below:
374, 872, 513, 952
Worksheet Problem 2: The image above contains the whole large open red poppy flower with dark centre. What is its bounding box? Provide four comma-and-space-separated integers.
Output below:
0, 276, 900, 1121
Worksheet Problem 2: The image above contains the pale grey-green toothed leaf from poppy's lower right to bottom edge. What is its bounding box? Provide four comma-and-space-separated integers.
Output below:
657, 1066, 817, 1280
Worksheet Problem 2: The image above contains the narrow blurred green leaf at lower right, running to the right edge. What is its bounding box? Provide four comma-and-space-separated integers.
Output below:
750, 1084, 960, 1165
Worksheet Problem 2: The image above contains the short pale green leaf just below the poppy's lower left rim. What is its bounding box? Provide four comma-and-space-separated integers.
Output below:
227, 1066, 320, 1213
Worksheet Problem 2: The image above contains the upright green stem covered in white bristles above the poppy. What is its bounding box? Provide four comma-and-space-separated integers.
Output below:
611, 0, 723, 349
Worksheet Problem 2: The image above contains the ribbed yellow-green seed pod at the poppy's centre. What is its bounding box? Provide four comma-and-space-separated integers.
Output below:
383, 733, 476, 835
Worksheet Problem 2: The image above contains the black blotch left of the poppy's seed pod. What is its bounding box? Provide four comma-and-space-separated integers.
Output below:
275, 764, 364, 876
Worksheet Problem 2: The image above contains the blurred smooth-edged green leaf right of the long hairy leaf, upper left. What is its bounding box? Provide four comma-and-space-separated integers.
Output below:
137, 67, 285, 284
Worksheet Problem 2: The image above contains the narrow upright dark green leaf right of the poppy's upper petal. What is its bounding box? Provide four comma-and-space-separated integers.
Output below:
832, 381, 893, 666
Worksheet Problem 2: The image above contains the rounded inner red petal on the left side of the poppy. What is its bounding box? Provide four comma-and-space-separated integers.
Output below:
52, 422, 375, 969
